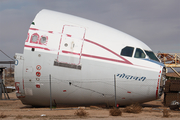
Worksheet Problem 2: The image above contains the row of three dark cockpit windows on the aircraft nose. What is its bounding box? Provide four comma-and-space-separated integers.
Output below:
121, 46, 159, 61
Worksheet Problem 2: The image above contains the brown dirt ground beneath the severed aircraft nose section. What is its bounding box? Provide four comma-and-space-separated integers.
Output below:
0, 92, 180, 120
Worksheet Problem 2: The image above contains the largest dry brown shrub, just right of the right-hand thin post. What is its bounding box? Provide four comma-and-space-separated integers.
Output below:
124, 103, 142, 113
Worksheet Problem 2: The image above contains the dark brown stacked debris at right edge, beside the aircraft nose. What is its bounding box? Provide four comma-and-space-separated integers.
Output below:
164, 80, 180, 106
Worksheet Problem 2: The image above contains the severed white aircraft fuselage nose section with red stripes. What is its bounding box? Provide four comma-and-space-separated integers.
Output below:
15, 10, 163, 106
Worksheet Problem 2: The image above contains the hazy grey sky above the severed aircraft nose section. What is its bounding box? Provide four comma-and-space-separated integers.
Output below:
0, 0, 180, 61
